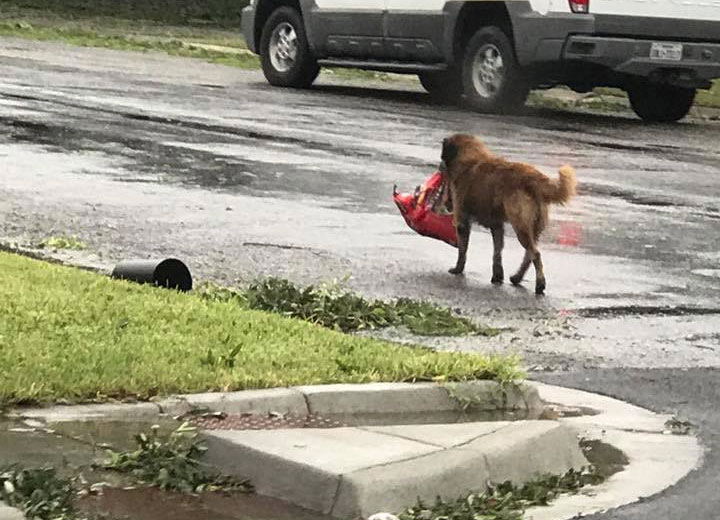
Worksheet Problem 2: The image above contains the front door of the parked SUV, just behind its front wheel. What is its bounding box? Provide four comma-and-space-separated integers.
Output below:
310, 0, 385, 59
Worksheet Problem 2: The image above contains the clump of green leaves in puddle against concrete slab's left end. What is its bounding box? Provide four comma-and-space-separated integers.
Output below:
100, 423, 253, 493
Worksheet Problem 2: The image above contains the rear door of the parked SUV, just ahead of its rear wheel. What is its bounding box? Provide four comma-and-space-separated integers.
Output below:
385, 0, 446, 63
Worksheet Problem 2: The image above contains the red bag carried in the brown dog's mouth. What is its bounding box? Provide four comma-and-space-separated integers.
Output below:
393, 172, 457, 247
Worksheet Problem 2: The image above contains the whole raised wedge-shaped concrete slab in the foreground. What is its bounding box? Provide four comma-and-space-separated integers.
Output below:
202, 421, 587, 519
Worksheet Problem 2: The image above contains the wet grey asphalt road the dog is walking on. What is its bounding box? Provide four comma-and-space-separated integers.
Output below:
0, 39, 720, 518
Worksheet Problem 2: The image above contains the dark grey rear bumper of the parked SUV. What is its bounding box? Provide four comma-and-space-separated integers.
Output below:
562, 35, 720, 87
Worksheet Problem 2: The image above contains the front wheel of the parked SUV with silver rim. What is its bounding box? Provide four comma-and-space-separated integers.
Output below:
260, 7, 320, 88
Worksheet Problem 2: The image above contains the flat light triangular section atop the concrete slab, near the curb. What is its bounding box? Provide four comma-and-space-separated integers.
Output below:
363, 422, 511, 448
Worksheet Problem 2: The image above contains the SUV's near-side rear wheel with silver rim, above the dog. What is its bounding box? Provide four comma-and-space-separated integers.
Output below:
462, 27, 530, 113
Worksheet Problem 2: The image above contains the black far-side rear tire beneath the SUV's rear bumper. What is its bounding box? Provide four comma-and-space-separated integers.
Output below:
627, 83, 697, 123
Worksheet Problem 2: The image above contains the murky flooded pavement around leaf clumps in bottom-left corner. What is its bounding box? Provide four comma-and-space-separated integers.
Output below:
0, 418, 325, 520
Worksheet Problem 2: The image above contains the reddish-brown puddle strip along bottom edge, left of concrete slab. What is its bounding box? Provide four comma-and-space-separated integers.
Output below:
77, 488, 329, 520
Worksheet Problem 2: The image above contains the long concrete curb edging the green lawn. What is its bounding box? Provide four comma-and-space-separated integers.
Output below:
10, 381, 543, 422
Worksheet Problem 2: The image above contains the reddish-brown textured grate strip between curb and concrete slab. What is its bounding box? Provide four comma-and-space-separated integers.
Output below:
190, 414, 347, 430
